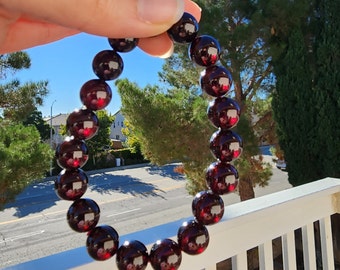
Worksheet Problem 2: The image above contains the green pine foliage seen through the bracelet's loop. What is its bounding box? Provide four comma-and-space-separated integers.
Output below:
116, 80, 213, 194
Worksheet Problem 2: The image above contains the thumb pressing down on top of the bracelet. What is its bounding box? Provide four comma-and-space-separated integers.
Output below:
6, 0, 185, 38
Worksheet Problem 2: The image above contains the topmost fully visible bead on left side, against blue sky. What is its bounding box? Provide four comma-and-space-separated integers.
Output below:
92, 50, 124, 81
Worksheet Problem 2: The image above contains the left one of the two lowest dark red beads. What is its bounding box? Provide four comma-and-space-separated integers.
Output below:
116, 240, 149, 270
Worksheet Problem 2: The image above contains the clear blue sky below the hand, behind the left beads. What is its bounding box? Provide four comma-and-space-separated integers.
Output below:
13, 34, 164, 117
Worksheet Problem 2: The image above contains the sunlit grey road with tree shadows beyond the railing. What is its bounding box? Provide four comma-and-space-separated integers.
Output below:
0, 159, 290, 268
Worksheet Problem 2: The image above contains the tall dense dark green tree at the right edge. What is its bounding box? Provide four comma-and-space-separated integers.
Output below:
273, 0, 340, 186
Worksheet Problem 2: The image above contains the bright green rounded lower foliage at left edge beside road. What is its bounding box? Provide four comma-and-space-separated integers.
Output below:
0, 120, 52, 210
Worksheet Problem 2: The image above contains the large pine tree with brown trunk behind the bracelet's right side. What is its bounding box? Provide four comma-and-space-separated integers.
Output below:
118, 0, 273, 200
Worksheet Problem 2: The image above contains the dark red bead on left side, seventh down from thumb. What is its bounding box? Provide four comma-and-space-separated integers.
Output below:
67, 199, 100, 232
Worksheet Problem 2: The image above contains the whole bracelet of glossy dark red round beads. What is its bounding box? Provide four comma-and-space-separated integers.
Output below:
55, 13, 242, 270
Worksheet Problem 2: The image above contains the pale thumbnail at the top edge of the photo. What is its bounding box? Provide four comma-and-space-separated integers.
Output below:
137, 0, 184, 24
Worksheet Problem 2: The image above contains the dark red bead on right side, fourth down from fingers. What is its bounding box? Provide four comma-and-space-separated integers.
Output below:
207, 97, 241, 129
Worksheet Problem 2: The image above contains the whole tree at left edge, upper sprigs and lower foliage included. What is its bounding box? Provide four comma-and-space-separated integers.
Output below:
0, 52, 52, 210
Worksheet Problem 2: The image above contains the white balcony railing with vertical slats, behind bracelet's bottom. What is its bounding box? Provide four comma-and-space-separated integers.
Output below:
73, 178, 340, 270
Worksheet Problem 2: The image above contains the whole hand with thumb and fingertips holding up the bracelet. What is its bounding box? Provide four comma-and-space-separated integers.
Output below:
0, 0, 201, 56
